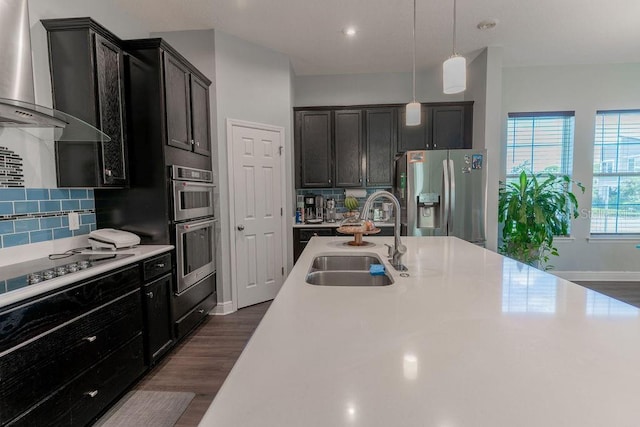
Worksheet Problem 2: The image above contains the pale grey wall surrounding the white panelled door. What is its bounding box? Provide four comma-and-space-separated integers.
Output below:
215, 31, 294, 310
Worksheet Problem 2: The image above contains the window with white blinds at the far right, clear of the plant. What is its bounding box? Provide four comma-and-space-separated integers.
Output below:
591, 110, 640, 234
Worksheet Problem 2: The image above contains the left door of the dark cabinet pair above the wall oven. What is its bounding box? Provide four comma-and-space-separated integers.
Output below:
164, 52, 192, 151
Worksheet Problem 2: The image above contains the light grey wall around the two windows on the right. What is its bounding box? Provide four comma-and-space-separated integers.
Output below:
500, 64, 640, 274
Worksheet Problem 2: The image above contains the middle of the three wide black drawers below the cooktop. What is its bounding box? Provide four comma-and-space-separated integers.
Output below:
0, 289, 142, 424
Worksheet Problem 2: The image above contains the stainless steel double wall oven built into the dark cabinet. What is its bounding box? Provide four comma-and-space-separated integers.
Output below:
171, 165, 217, 295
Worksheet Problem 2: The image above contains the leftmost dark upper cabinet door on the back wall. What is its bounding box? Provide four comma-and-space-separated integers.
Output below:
296, 111, 333, 187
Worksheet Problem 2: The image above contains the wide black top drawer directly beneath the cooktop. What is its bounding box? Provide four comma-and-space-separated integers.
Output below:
0, 265, 140, 354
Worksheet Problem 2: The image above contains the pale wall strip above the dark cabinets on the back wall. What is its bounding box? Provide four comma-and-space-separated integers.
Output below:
294, 67, 463, 107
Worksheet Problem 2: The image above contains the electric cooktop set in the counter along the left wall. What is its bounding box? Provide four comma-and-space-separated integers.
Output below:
0, 253, 133, 294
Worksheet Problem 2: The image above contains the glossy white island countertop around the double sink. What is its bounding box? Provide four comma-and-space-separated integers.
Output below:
200, 236, 640, 427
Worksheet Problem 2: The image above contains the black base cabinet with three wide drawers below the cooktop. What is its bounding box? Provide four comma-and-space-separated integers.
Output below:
0, 264, 145, 426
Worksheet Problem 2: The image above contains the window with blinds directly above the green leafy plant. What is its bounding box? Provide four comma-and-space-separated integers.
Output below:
507, 111, 574, 181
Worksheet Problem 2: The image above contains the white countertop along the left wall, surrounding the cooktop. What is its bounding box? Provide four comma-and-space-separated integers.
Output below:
0, 245, 173, 308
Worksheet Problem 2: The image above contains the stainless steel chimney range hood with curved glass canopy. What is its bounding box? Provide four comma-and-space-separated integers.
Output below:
0, 0, 111, 142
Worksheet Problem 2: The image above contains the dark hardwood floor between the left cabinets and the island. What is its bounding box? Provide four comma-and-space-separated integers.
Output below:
135, 302, 271, 427
